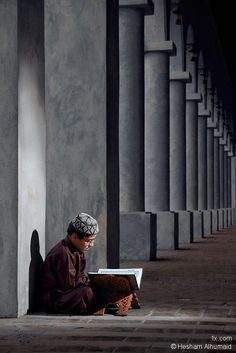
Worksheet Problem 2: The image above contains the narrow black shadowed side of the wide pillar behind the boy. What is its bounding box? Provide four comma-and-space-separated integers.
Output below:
106, 0, 120, 268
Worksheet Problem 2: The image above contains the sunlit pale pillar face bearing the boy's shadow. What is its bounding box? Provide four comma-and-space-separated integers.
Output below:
18, 0, 46, 315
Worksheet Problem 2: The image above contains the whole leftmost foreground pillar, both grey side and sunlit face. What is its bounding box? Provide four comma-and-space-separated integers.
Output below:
0, 0, 46, 317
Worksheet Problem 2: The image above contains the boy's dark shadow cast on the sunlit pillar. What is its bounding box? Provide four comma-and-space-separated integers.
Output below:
27, 230, 43, 314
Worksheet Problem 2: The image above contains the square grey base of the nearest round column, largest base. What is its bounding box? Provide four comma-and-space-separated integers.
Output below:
120, 212, 157, 261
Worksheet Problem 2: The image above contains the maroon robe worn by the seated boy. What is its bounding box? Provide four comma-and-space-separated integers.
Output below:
42, 237, 94, 314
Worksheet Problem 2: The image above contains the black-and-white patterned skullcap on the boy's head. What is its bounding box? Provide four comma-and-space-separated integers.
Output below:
71, 213, 99, 236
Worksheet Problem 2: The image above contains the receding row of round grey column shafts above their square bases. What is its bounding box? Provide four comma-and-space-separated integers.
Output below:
120, 2, 236, 216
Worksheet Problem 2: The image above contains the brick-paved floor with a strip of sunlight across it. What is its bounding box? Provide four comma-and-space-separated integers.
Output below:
0, 227, 236, 353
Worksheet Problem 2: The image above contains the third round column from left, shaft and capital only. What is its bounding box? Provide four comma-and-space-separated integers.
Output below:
170, 72, 190, 210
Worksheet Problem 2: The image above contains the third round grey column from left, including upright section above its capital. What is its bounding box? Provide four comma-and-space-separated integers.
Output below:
169, 2, 191, 210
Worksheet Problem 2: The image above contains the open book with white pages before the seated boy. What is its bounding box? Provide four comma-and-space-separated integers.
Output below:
88, 268, 143, 290
